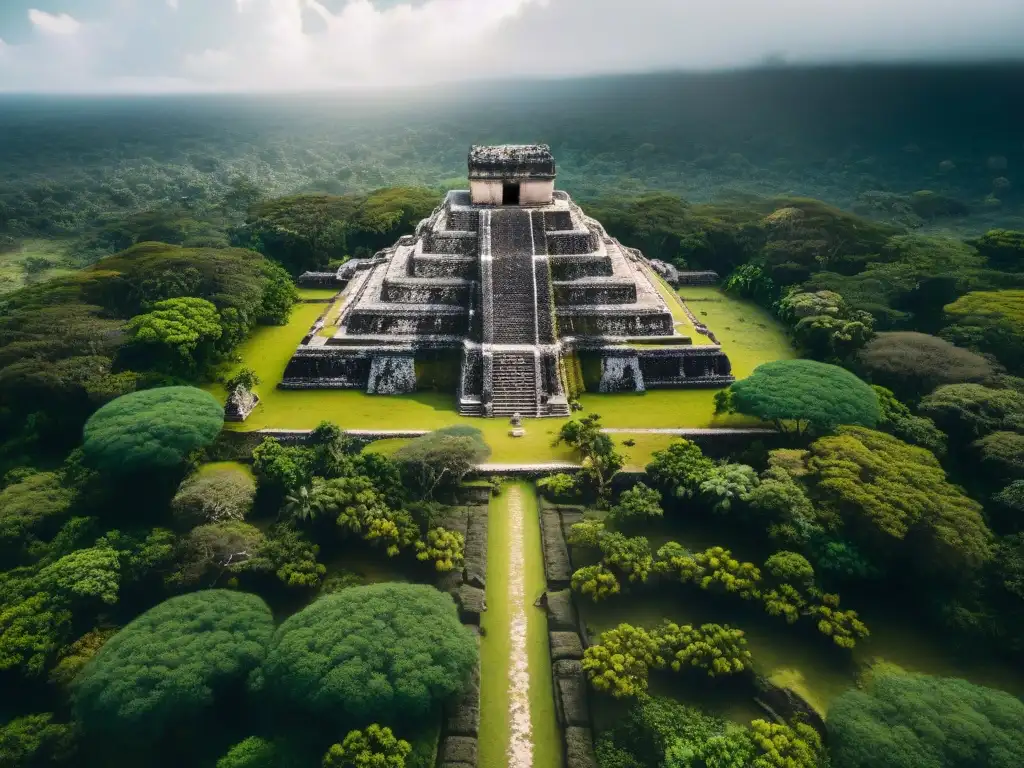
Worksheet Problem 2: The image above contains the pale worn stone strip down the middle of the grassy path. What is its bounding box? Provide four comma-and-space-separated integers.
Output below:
505, 485, 534, 768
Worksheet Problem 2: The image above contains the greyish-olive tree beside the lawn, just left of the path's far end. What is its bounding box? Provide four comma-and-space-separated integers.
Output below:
392, 426, 490, 499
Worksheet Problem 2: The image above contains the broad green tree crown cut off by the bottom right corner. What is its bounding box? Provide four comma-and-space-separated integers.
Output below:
828, 669, 1024, 768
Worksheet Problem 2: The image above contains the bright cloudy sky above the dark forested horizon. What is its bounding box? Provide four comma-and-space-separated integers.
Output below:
0, 0, 1024, 92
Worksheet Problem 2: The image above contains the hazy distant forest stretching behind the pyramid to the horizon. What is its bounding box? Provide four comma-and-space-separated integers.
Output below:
0, 66, 1024, 252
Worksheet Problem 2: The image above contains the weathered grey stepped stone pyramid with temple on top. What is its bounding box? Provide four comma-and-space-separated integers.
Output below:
280, 144, 732, 417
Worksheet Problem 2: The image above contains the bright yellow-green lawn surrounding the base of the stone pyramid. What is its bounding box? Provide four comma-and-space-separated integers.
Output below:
207, 288, 795, 466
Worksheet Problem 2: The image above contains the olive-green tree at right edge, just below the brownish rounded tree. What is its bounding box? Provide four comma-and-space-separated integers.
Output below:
919, 384, 1024, 444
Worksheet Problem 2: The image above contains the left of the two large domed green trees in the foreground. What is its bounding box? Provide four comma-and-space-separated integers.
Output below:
72, 590, 273, 745
